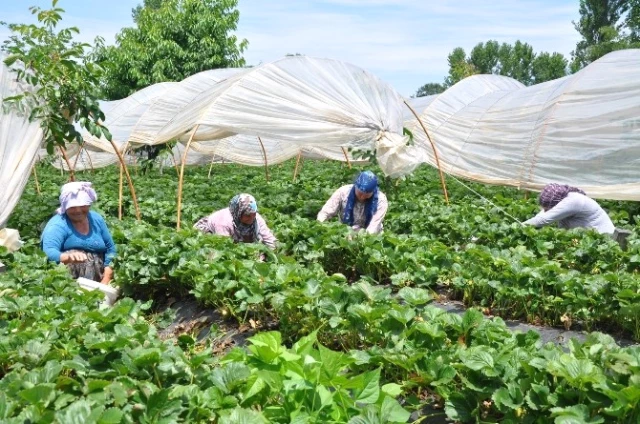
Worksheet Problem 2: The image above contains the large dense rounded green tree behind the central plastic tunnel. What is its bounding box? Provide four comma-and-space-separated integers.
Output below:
98, 0, 248, 99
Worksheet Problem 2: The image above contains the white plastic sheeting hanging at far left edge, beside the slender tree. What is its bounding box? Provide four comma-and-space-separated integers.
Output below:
0, 57, 43, 228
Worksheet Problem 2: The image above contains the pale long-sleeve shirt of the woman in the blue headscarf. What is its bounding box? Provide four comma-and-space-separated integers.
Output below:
318, 184, 389, 234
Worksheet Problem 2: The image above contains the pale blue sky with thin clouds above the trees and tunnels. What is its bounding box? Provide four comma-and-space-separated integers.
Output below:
0, 0, 580, 96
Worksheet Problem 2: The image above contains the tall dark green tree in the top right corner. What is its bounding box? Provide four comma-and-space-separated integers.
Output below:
571, 0, 637, 72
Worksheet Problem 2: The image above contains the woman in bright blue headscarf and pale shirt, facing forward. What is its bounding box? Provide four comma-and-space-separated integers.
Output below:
318, 171, 388, 234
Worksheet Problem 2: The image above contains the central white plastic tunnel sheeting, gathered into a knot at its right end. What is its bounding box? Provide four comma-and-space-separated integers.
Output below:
57, 57, 420, 174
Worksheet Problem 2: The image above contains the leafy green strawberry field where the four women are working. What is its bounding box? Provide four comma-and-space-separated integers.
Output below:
0, 162, 640, 424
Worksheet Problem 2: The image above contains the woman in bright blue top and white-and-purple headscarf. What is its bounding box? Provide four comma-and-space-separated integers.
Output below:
41, 181, 116, 284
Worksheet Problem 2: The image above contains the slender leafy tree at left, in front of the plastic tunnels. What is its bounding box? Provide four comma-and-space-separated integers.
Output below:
2, 0, 111, 153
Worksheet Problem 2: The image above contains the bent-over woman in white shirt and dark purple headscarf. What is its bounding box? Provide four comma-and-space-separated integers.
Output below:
524, 183, 615, 234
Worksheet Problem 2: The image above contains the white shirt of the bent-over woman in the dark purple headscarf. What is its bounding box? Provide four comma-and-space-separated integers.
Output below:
524, 192, 615, 234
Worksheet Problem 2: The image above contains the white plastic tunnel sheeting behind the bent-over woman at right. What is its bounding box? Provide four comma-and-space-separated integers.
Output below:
405, 50, 640, 200
